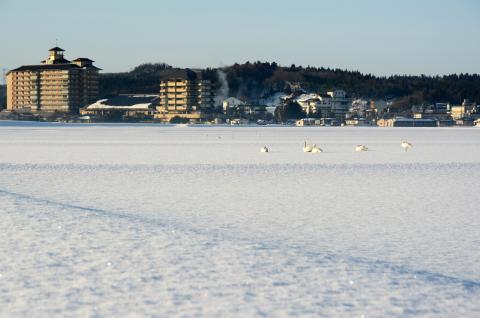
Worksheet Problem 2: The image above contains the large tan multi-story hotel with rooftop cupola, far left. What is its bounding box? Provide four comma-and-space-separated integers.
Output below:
7, 47, 100, 113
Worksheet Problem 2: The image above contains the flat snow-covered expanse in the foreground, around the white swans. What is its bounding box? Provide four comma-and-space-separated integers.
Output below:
0, 122, 480, 317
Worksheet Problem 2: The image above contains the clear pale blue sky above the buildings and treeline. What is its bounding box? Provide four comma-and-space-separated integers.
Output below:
0, 0, 480, 75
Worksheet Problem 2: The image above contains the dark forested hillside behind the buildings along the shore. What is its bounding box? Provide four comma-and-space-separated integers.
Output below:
100, 62, 480, 108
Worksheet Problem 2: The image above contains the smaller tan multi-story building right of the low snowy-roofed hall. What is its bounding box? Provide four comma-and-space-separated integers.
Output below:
155, 69, 213, 121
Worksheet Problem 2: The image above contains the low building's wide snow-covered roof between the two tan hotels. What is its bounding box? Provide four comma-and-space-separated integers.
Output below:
86, 95, 159, 110
